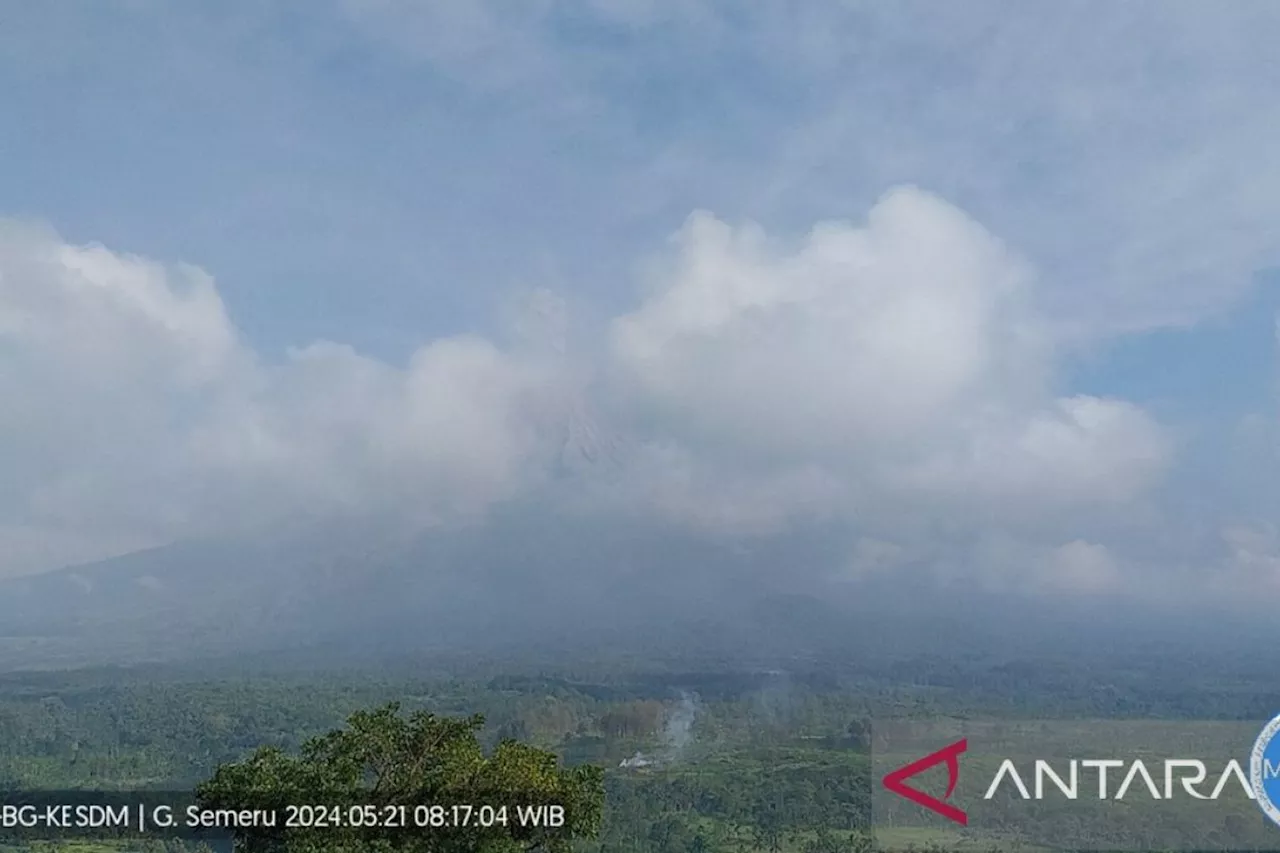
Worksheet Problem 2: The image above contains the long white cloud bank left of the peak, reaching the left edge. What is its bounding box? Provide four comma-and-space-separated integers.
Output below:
0, 217, 561, 571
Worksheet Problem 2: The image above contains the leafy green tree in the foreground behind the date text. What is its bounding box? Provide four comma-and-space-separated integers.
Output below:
196, 703, 604, 853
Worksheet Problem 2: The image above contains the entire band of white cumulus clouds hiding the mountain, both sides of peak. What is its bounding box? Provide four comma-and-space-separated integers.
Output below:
0, 188, 1171, 587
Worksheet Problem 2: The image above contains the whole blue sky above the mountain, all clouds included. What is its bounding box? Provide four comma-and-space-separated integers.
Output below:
0, 0, 1280, 601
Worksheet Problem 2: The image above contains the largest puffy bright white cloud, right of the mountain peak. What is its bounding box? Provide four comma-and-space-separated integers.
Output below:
613, 188, 1171, 503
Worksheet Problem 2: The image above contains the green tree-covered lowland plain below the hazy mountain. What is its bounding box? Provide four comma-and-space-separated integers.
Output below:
0, 648, 1277, 853
